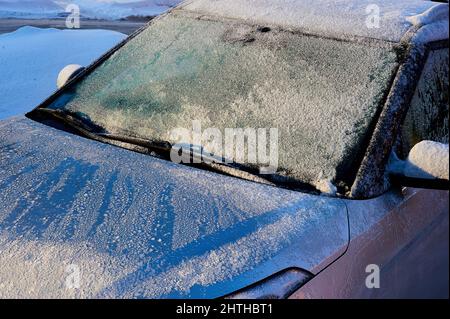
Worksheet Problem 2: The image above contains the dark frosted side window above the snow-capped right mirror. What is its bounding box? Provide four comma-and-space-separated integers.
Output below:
402, 48, 449, 156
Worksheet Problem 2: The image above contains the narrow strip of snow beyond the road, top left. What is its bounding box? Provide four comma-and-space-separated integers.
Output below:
0, 0, 180, 20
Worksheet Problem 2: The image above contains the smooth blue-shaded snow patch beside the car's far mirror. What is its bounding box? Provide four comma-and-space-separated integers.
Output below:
0, 27, 126, 120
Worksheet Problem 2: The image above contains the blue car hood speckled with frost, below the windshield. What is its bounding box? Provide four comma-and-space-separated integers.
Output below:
0, 117, 348, 298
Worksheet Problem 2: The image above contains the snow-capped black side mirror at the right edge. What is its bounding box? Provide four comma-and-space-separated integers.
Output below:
388, 141, 449, 190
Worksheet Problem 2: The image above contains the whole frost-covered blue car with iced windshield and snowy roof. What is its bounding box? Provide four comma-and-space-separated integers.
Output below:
0, 0, 449, 299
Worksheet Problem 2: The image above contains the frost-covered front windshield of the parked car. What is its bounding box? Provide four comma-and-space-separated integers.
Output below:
44, 11, 397, 192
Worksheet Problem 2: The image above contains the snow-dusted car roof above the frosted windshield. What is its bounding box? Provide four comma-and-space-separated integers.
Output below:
179, 0, 448, 42
